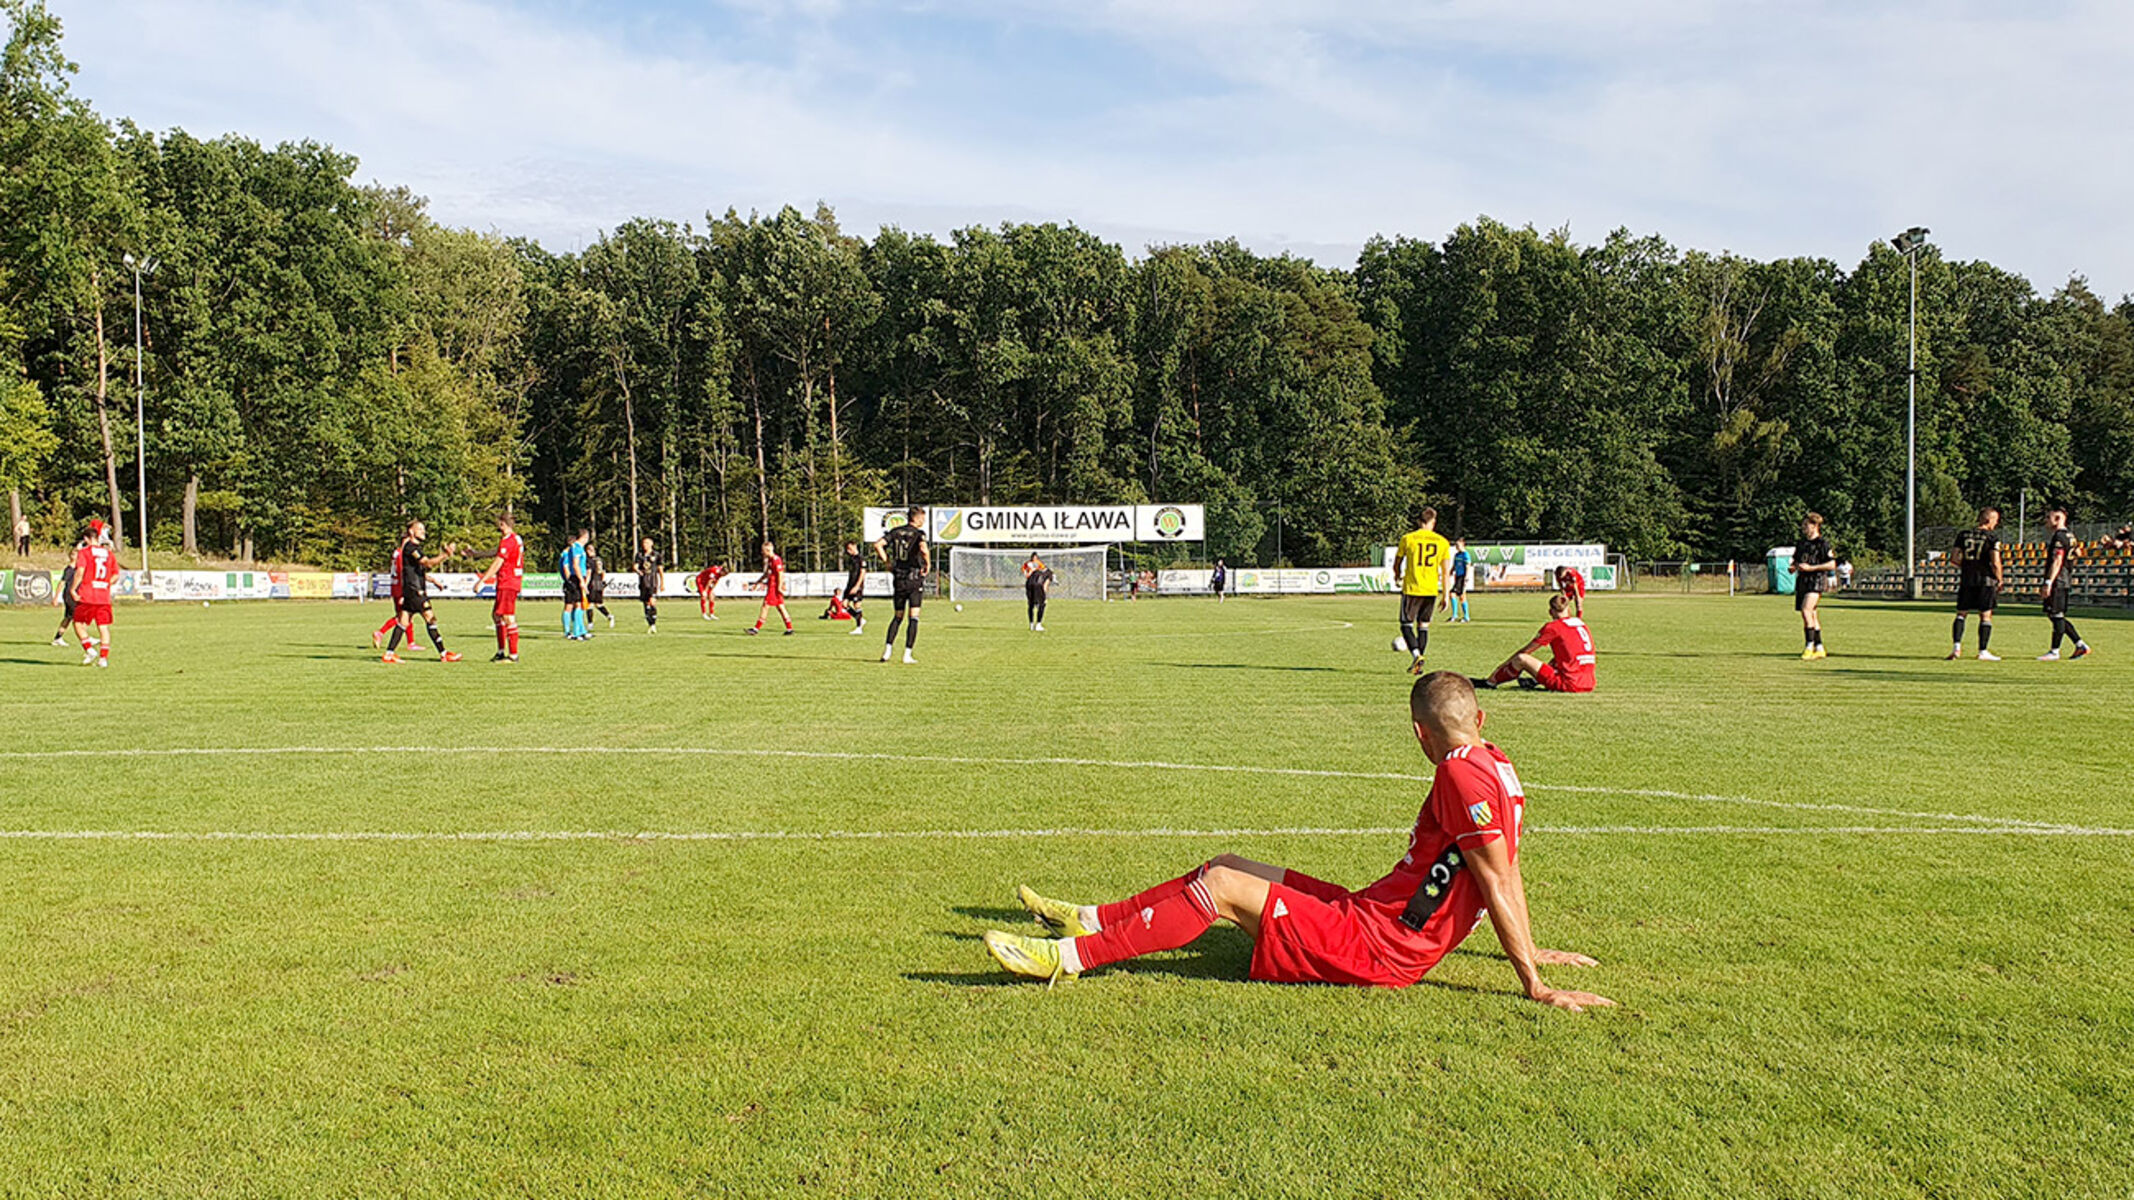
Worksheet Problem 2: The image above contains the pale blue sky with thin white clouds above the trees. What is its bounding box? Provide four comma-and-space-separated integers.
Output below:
49, 0, 2134, 299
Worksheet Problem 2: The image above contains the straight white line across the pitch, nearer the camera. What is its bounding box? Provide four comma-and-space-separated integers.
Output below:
0, 824, 2134, 841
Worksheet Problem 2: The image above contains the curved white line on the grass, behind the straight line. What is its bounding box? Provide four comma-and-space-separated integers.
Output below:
0, 745, 2079, 831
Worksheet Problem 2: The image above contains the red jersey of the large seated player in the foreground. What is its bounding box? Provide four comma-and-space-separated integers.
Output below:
1338, 743, 1526, 976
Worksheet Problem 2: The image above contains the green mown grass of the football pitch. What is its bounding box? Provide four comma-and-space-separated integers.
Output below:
0, 596, 2134, 1198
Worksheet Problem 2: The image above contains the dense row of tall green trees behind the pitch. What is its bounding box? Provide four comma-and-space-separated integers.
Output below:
0, 0, 2134, 566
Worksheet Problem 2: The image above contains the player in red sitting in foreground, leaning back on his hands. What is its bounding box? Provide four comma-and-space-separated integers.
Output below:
986, 670, 1613, 1012
